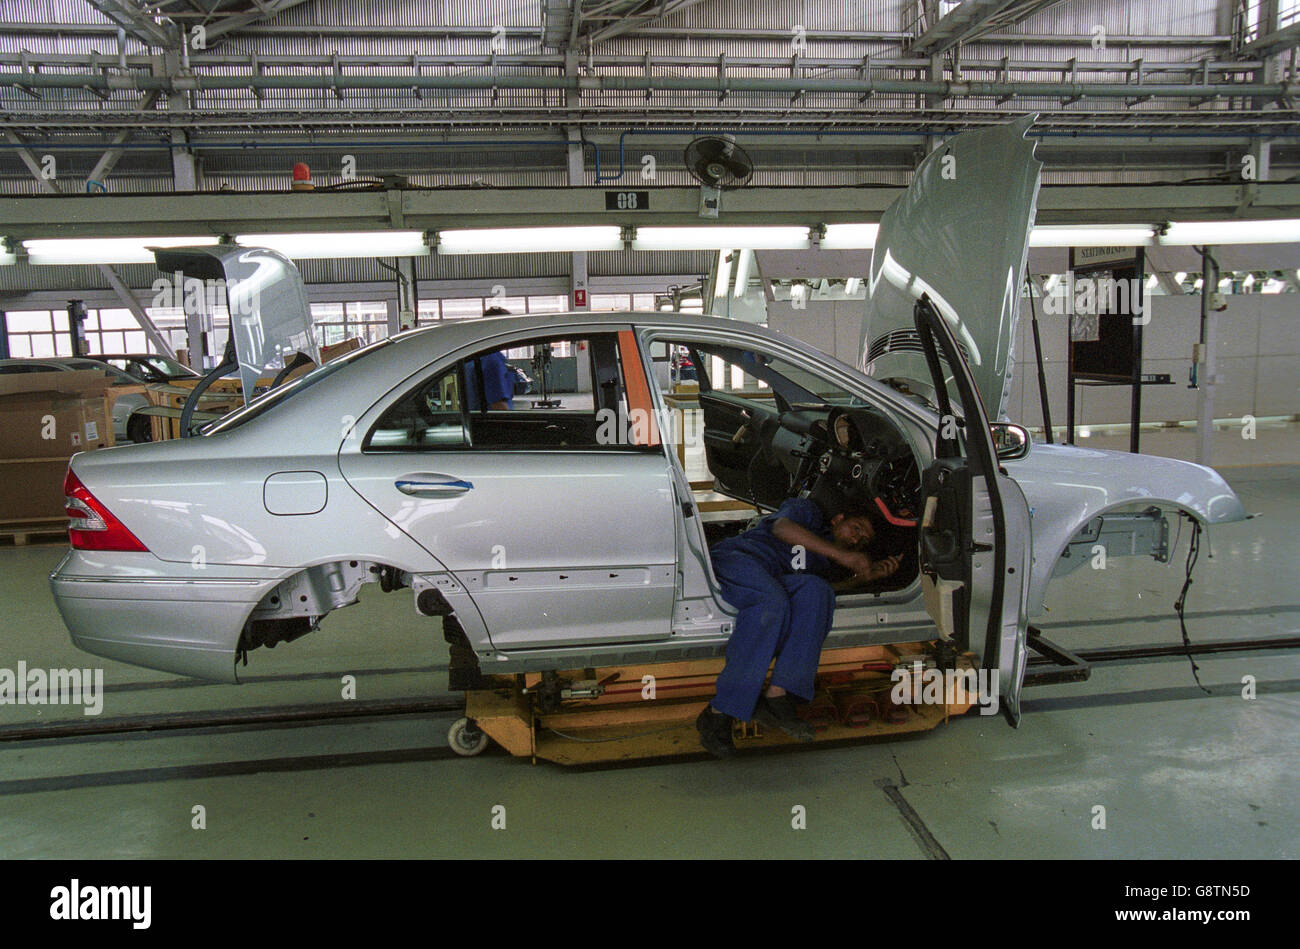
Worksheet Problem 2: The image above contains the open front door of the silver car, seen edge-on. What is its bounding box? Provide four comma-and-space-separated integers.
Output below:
914, 296, 1031, 724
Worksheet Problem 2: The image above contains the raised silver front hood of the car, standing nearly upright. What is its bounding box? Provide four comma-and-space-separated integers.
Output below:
858, 116, 1043, 419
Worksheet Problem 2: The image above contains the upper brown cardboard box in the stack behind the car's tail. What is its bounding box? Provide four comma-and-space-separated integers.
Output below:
0, 369, 113, 457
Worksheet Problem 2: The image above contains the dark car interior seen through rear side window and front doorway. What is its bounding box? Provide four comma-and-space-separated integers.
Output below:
364, 333, 920, 595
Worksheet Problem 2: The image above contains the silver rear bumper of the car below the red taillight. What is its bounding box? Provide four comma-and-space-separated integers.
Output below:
49, 550, 283, 683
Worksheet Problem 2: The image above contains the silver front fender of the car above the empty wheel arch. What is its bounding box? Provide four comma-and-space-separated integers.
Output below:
1005, 443, 1245, 615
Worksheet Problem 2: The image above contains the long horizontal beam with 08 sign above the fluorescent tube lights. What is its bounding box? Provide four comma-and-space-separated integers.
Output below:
0, 182, 1300, 239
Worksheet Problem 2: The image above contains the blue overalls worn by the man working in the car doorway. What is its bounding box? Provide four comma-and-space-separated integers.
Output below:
709, 498, 835, 722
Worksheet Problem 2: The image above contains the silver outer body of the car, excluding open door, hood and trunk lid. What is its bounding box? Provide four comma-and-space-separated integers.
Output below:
51, 313, 1244, 707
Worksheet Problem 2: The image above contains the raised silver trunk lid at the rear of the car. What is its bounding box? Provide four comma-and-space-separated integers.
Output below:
153, 244, 321, 402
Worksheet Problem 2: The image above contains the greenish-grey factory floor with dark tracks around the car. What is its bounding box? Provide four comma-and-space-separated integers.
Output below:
0, 425, 1300, 859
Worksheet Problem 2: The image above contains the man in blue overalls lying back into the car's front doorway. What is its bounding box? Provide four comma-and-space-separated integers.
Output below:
696, 498, 901, 758
